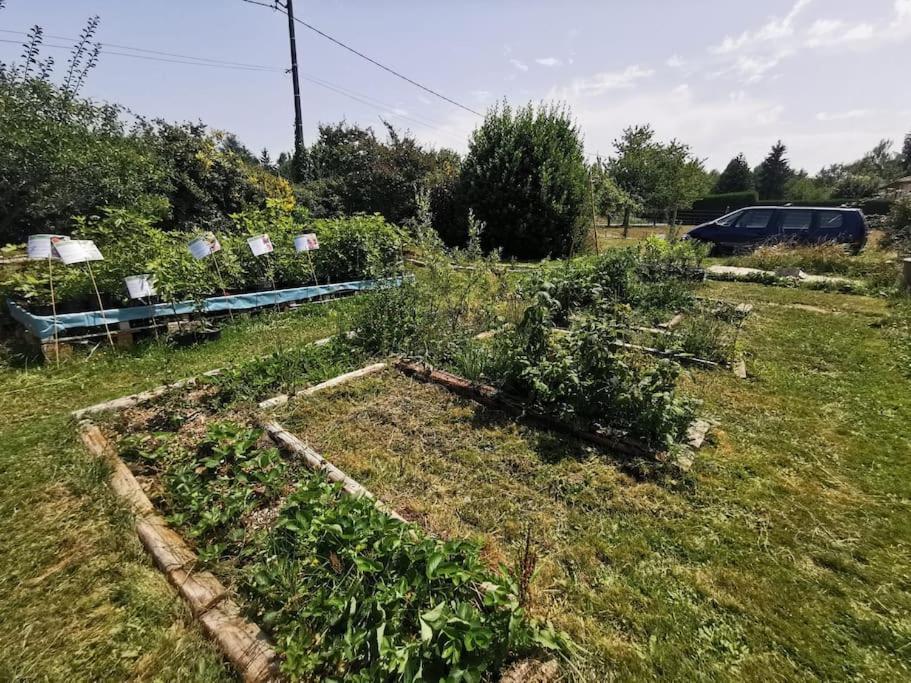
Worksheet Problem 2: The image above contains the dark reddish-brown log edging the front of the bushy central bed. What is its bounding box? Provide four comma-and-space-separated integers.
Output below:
395, 359, 655, 457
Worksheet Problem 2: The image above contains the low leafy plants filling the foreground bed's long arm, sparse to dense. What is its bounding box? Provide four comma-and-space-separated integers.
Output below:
122, 422, 569, 683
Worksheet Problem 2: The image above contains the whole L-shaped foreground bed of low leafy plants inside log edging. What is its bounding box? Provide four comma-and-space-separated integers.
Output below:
81, 350, 566, 681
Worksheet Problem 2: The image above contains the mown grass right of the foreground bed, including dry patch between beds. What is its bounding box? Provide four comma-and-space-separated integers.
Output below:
274, 285, 911, 680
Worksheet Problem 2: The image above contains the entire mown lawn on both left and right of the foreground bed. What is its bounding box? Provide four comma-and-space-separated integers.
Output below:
0, 283, 911, 681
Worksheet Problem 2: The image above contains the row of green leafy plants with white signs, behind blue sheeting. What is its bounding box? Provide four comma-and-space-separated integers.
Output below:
0, 200, 401, 309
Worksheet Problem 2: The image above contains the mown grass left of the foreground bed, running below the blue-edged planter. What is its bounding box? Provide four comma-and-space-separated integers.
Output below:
0, 302, 347, 681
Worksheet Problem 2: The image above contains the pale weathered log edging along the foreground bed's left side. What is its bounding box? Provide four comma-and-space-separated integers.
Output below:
79, 420, 282, 683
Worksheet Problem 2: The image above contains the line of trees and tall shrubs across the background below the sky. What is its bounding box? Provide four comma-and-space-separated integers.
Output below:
0, 10, 911, 258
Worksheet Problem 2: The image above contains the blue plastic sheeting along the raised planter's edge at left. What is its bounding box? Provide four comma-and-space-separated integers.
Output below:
7, 276, 410, 339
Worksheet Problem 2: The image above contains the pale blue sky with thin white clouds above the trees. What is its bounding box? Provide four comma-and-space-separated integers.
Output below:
0, 0, 911, 173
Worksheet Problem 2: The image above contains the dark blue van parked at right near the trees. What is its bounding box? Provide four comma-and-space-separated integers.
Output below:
686, 206, 868, 251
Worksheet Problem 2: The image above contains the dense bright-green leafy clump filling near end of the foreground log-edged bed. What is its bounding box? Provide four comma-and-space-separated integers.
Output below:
244, 478, 566, 683
